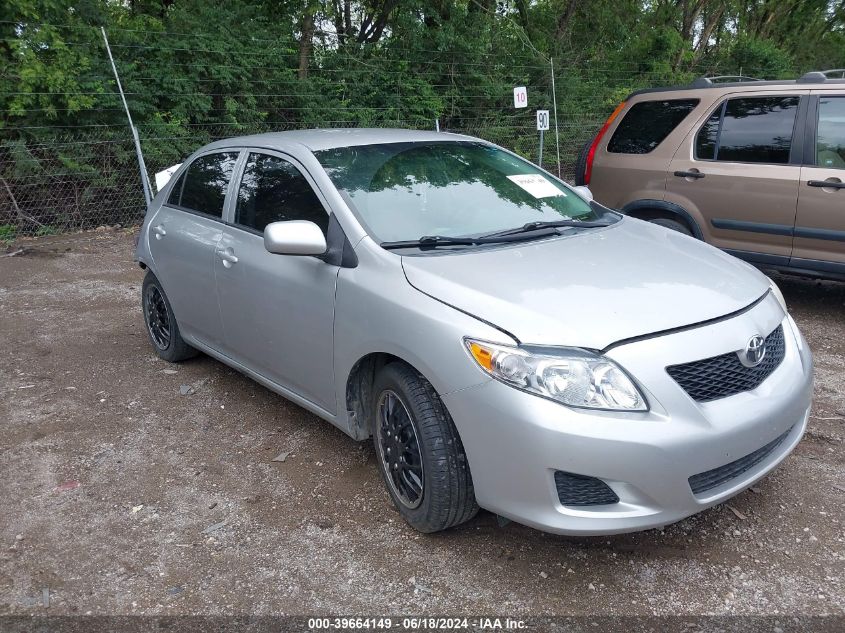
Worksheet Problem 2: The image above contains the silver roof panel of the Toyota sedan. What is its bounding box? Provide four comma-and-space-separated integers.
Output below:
203, 128, 479, 152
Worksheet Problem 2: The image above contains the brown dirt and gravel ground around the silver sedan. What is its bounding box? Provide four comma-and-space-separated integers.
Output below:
0, 232, 845, 615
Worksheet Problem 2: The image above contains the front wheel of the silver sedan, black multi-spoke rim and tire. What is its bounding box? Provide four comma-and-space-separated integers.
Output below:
372, 363, 478, 532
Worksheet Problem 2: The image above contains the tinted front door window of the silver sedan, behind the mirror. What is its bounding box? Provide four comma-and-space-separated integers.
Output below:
235, 154, 329, 234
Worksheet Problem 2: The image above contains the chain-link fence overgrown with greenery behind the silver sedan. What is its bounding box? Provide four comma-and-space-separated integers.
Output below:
0, 22, 748, 240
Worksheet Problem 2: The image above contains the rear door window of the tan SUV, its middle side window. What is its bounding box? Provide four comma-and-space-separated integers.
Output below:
695, 96, 799, 165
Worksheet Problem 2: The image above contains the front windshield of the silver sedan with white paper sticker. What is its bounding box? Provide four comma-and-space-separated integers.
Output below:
315, 141, 598, 242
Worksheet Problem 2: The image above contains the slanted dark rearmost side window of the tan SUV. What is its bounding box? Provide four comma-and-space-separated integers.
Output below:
607, 99, 698, 154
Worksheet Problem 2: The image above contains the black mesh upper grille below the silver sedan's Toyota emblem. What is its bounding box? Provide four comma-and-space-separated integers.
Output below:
666, 325, 786, 402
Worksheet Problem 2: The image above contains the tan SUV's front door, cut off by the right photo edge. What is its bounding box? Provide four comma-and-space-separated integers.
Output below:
791, 91, 845, 274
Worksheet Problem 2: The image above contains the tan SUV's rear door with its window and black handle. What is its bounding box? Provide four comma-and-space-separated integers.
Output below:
666, 91, 809, 265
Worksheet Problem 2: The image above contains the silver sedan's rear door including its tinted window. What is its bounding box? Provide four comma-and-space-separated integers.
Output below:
148, 150, 239, 348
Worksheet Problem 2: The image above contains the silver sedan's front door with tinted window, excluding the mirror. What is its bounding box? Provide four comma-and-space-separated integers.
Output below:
214, 152, 339, 414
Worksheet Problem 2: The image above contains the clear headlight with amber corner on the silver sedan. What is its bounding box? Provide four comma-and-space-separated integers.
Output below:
464, 339, 648, 411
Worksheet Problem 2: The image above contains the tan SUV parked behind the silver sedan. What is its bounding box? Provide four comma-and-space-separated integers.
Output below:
576, 71, 845, 279
